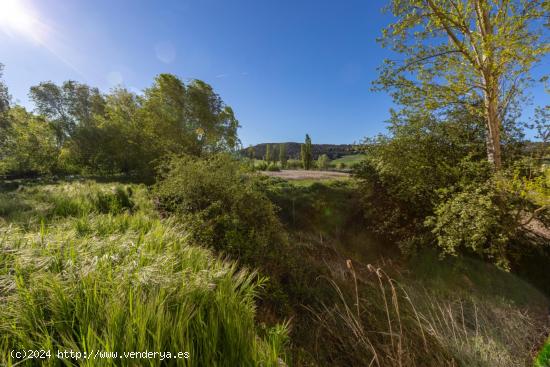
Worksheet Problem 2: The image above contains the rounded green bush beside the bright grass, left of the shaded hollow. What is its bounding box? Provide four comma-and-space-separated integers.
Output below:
155, 155, 286, 262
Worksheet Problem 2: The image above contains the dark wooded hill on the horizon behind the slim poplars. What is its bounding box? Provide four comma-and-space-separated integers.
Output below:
242, 142, 359, 159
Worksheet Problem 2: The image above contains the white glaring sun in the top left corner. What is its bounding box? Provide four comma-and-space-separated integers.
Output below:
0, 0, 37, 38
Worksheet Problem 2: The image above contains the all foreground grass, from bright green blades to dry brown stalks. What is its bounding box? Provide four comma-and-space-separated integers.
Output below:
0, 177, 550, 367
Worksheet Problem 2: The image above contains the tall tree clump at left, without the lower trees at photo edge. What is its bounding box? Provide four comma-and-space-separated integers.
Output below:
24, 74, 240, 181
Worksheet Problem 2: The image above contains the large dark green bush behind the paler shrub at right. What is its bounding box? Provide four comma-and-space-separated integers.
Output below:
355, 111, 491, 251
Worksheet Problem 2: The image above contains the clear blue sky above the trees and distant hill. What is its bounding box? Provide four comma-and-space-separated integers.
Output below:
0, 0, 547, 145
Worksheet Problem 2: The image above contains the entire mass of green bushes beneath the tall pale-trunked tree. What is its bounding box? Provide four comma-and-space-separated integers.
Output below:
356, 105, 548, 269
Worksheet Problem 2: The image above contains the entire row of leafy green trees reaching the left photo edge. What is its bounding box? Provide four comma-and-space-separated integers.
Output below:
0, 74, 239, 181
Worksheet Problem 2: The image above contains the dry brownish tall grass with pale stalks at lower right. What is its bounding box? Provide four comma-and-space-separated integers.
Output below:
310, 265, 547, 367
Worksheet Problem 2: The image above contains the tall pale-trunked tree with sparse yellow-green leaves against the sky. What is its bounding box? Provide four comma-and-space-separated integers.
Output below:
377, 0, 550, 170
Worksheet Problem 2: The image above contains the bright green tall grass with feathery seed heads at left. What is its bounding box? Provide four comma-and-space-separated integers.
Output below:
0, 183, 287, 366
